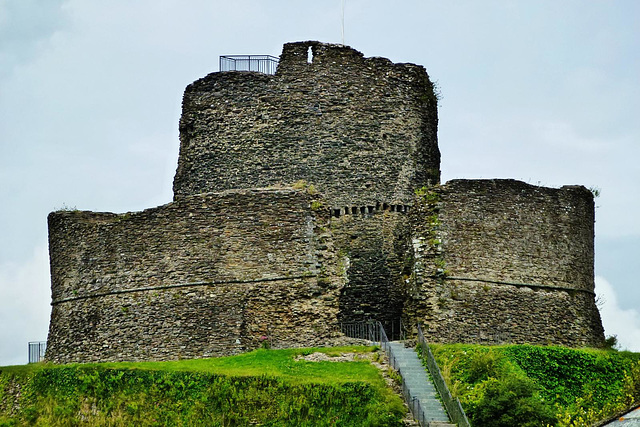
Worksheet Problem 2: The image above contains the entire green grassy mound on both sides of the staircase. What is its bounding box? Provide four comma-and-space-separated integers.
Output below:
5, 345, 640, 427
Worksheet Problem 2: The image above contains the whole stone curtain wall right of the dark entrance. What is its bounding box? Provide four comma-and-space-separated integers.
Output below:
409, 180, 604, 346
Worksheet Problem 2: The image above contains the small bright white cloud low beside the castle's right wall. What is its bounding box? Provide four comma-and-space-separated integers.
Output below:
596, 276, 640, 352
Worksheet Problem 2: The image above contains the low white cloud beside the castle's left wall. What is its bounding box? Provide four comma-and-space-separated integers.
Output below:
0, 245, 51, 366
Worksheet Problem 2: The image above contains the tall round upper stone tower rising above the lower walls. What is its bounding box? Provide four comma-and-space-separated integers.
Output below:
174, 42, 440, 208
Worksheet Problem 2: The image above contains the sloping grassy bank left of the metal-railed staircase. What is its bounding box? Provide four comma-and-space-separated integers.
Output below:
0, 347, 405, 426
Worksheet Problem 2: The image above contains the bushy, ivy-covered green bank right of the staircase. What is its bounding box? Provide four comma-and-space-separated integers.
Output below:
431, 344, 640, 427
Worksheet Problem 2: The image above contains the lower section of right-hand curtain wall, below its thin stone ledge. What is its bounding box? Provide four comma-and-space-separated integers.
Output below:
424, 280, 604, 347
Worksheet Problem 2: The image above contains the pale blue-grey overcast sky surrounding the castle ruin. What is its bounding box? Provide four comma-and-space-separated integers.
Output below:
0, 0, 640, 366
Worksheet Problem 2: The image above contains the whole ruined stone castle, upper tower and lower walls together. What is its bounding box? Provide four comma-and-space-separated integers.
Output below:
46, 42, 603, 362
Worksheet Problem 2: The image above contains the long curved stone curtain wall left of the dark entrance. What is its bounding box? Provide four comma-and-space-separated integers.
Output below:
47, 189, 342, 362
